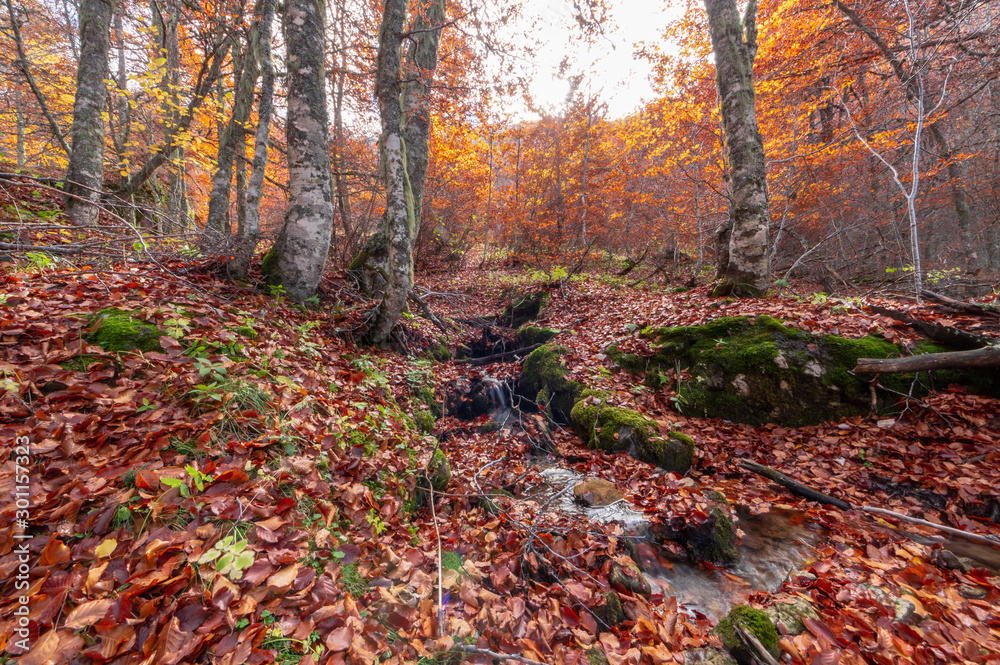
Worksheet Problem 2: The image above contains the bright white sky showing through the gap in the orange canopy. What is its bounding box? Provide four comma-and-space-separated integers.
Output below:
531, 0, 670, 118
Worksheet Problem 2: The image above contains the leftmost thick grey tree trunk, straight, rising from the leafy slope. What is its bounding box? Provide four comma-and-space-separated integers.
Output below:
66, 0, 111, 226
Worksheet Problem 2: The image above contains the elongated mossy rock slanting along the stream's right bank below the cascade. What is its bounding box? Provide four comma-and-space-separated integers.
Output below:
570, 390, 694, 475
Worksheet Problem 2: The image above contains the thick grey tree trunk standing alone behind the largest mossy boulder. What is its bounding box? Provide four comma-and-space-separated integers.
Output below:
705, 0, 770, 297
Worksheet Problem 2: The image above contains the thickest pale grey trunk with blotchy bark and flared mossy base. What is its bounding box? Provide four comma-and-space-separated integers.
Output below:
263, 0, 333, 300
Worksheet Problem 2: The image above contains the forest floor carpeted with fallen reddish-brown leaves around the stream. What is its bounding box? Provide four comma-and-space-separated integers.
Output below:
0, 246, 1000, 665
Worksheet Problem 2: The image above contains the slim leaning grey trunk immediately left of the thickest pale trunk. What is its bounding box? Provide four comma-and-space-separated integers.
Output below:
228, 0, 275, 279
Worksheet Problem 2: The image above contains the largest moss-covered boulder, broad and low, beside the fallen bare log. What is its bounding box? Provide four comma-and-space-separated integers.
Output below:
625, 316, 905, 427
